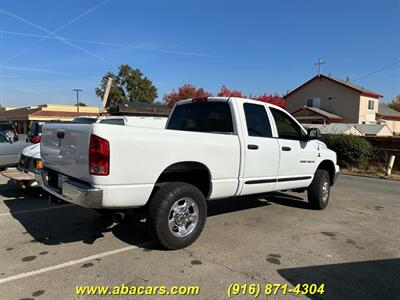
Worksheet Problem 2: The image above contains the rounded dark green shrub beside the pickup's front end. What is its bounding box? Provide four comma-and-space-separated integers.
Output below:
322, 134, 372, 168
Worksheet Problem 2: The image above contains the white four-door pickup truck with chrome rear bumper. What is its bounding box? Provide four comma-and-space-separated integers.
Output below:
36, 97, 339, 249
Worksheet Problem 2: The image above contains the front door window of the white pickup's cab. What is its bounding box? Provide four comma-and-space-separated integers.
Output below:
270, 107, 304, 140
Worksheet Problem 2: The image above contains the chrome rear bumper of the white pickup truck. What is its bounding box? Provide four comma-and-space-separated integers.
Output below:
35, 170, 103, 208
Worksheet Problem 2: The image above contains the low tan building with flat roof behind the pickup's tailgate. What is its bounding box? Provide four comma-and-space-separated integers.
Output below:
0, 104, 99, 133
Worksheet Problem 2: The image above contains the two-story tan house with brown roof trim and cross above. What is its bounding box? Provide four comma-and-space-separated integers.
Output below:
283, 75, 383, 124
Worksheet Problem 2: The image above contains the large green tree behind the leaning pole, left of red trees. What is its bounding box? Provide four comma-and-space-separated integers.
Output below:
96, 65, 157, 104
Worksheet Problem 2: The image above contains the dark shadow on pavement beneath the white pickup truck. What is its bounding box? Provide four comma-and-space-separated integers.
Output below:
0, 184, 310, 249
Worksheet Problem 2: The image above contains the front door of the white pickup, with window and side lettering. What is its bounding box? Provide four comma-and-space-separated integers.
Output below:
269, 107, 318, 190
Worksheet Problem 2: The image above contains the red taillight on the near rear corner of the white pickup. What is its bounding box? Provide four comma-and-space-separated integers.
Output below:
89, 134, 110, 176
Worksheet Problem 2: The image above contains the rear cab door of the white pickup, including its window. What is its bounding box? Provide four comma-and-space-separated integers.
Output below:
239, 102, 279, 195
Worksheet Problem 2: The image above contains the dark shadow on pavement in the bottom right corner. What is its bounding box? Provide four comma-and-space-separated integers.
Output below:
278, 258, 400, 299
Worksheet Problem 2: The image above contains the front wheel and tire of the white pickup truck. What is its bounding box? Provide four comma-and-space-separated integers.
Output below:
307, 169, 331, 210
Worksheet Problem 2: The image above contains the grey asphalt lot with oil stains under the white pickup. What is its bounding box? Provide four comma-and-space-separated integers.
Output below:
0, 175, 400, 299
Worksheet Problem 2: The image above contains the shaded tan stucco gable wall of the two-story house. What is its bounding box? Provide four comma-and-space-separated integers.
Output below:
286, 78, 362, 123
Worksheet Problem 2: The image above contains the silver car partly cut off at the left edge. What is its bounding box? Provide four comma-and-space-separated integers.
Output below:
0, 132, 27, 169
